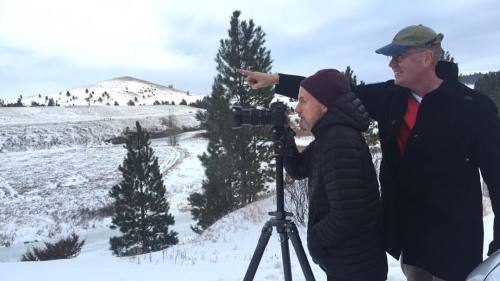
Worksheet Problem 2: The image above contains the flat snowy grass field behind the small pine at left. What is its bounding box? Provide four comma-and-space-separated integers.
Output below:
0, 134, 200, 246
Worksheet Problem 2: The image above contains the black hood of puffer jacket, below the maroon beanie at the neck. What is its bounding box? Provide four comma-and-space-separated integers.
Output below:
311, 92, 370, 137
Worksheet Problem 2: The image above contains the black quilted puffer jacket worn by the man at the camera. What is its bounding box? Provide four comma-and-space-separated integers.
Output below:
284, 93, 387, 281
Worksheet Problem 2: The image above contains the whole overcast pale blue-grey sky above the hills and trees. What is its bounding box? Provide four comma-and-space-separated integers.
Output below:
0, 0, 500, 98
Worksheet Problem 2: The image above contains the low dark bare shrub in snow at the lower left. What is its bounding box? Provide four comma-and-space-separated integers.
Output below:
21, 233, 85, 261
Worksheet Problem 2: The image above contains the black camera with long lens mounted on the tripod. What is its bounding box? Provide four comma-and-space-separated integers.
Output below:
231, 102, 288, 129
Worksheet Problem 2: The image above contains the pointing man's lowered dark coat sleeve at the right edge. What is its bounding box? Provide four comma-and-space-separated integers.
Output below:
476, 95, 500, 255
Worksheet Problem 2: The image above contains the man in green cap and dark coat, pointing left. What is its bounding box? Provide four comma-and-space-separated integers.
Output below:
241, 25, 500, 281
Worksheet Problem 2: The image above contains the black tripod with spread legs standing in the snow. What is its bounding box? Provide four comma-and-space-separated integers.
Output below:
243, 117, 315, 281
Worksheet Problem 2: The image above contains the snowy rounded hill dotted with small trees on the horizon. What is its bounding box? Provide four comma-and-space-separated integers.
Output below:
6, 76, 203, 106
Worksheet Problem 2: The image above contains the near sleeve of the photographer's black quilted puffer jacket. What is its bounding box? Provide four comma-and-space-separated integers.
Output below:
311, 136, 371, 247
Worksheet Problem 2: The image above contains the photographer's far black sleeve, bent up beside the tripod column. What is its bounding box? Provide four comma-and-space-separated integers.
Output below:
283, 129, 314, 180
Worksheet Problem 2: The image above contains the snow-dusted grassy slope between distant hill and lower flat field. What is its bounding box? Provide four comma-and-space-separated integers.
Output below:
0, 105, 199, 152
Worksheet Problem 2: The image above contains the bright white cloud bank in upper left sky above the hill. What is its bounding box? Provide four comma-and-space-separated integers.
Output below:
0, 0, 194, 69
